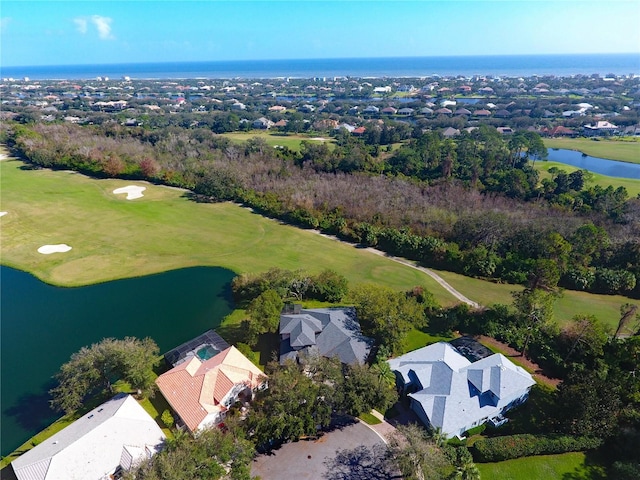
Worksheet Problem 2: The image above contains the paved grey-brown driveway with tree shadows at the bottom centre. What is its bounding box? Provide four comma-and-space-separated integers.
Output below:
251, 422, 384, 480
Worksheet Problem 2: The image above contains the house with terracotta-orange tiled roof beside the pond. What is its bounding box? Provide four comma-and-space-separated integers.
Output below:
156, 346, 265, 433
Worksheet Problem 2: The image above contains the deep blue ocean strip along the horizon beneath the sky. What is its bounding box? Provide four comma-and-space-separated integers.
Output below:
0, 53, 640, 80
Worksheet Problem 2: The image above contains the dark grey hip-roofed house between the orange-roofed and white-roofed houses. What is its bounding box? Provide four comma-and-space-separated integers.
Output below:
280, 305, 373, 364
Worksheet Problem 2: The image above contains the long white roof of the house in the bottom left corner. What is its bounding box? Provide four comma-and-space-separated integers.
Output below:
11, 395, 165, 480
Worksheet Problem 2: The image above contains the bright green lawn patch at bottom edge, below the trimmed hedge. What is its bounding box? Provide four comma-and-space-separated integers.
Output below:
476, 452, 606, 480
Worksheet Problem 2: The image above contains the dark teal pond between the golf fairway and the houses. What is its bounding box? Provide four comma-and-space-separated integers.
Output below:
0, 267, 235, 455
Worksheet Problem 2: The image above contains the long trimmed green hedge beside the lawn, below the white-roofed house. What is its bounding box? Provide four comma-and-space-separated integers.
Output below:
470, 434, 602, 462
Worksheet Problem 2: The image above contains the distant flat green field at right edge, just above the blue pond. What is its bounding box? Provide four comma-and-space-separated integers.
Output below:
544, 137, 640, 163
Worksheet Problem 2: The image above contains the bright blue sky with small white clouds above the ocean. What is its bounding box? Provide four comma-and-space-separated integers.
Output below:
0, 0, 640, 66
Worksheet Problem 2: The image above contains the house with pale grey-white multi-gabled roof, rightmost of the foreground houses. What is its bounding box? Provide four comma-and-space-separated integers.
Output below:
389, 342, 535, 437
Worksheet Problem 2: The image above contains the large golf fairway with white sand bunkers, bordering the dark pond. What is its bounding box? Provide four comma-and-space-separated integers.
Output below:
0, 160, 456, 305
